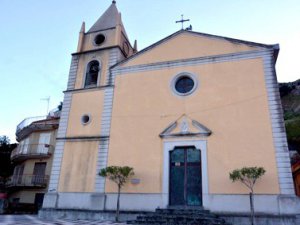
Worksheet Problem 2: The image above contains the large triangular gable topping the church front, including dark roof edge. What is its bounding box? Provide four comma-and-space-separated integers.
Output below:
119, 30, 274, 67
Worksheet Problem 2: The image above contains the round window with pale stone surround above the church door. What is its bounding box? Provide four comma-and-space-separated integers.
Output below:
171, 72, 198, 96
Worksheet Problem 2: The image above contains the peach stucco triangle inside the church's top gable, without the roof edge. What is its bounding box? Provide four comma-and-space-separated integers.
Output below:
122, 33, 257, 67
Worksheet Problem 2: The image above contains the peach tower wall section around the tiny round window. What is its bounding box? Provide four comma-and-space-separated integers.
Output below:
67, 90, 104, 137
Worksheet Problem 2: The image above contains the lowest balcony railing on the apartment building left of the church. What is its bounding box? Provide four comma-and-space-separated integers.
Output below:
6, 174, 49, 188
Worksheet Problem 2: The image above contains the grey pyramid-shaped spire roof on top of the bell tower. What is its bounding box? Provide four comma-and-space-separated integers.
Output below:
87, 2, 120, 33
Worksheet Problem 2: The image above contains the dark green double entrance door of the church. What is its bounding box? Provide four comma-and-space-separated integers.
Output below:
169, 146, 202, 206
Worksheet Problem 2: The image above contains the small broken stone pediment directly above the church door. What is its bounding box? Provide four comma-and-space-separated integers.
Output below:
159, 115, 212, 138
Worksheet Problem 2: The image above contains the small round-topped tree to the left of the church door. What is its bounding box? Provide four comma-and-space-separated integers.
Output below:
99, 166, 134, 222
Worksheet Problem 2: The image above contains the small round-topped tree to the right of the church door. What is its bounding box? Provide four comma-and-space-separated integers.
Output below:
229, 167, 266, 225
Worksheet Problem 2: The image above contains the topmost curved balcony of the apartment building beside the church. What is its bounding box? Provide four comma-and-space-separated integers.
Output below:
16, 115, 59, 141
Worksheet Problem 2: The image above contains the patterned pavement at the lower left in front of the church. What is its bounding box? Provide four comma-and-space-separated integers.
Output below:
0, 215, 126, 225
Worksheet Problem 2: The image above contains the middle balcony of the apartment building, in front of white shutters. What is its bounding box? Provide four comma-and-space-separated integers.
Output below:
10, 144, 54, 161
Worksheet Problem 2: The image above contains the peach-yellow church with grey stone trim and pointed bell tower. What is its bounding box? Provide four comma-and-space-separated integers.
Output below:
42, 1, 300, 221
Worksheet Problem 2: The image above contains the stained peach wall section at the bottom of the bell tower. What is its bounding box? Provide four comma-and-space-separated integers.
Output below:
58, 141, 99, 192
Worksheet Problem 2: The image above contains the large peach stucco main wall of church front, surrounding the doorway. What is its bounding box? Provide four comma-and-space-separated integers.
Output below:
106, 57, 279, 194
